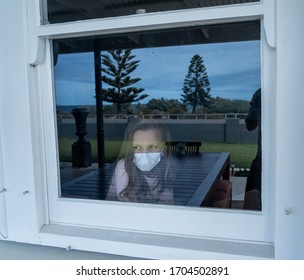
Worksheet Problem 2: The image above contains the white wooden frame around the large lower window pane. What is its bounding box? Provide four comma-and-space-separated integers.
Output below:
28, 0, 276, 258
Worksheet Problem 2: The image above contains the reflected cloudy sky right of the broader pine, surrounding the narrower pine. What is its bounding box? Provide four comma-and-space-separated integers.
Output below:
134, 41, 261, 100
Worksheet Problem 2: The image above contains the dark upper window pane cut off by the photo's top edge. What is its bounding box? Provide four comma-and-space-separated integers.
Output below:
47, 0, 260, 23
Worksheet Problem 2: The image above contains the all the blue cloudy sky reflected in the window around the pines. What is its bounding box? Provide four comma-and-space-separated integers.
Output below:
55, 41, 261, 106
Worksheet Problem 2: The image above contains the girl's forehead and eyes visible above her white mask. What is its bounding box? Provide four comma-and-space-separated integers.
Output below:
132, 129, 164, 153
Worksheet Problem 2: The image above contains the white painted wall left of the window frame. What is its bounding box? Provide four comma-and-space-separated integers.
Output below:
0, 1, 35, 242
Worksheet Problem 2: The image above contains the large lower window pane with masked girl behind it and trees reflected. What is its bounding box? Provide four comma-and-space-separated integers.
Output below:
53, 21, 261, 210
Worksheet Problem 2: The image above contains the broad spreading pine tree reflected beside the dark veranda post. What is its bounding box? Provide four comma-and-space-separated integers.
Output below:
101, 50, 148, 114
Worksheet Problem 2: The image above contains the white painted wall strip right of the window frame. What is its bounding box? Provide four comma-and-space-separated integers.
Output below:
274, 0, 304, 259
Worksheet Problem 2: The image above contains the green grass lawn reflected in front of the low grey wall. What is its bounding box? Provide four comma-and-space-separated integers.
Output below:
59, 139, 257, 168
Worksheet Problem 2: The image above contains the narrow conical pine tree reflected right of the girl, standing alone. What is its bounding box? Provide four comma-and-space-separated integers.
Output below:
181, 54, 212, 113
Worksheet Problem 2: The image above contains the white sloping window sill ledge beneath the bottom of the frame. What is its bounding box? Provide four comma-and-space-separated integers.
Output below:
40, 225, 274, 259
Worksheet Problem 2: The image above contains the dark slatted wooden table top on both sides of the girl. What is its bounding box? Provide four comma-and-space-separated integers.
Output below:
61, 153, 230, 206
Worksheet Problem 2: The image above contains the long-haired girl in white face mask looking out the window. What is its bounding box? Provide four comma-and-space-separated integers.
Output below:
107, 120, 174, 204
